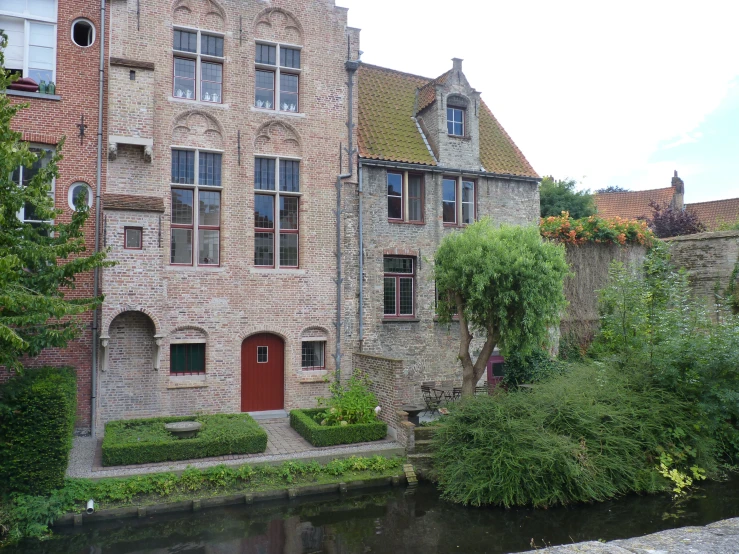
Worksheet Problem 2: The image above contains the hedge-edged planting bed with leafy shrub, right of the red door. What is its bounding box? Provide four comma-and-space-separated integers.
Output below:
290, 376, 387, 446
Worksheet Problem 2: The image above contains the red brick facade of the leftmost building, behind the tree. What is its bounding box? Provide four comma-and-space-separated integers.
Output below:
0, 0, 105, 429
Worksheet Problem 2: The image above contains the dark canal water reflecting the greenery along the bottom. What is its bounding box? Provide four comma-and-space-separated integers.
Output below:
3, 477, 739, 554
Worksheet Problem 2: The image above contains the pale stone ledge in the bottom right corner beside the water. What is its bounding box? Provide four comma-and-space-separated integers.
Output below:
523, 518, 739, 554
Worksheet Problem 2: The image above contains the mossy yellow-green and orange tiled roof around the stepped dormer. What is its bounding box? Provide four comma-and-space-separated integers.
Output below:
358, 63, 539, 179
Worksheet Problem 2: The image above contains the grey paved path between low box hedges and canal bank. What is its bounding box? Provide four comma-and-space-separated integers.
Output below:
67, 418, 403, 479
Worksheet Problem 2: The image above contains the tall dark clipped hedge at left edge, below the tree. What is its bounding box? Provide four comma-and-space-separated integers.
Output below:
0, 367, 77, 494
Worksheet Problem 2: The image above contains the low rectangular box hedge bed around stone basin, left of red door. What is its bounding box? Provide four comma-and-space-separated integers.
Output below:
103, 414, 267, 466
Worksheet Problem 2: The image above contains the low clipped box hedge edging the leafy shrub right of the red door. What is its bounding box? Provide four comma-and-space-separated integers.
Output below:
290, 408, 387, 446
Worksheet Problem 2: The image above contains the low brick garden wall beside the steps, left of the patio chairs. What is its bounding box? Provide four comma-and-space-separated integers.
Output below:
352, 352, 414, 449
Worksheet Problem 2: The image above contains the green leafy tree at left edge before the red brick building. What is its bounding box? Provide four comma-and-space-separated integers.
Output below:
0, 34, 110, 370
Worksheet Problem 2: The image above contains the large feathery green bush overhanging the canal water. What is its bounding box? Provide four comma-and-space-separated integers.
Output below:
434, 364, 715, 507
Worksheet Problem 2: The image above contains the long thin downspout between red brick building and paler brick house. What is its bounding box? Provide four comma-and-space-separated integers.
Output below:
90, 0, 105, 438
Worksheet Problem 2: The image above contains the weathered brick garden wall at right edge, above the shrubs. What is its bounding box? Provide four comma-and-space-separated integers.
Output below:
666, 227, 739, 307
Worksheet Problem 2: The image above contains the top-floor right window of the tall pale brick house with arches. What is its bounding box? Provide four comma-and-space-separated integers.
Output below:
254, 42, 302, 112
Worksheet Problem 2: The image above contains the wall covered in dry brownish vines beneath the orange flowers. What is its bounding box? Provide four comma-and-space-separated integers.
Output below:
560, 243, 647, 344
